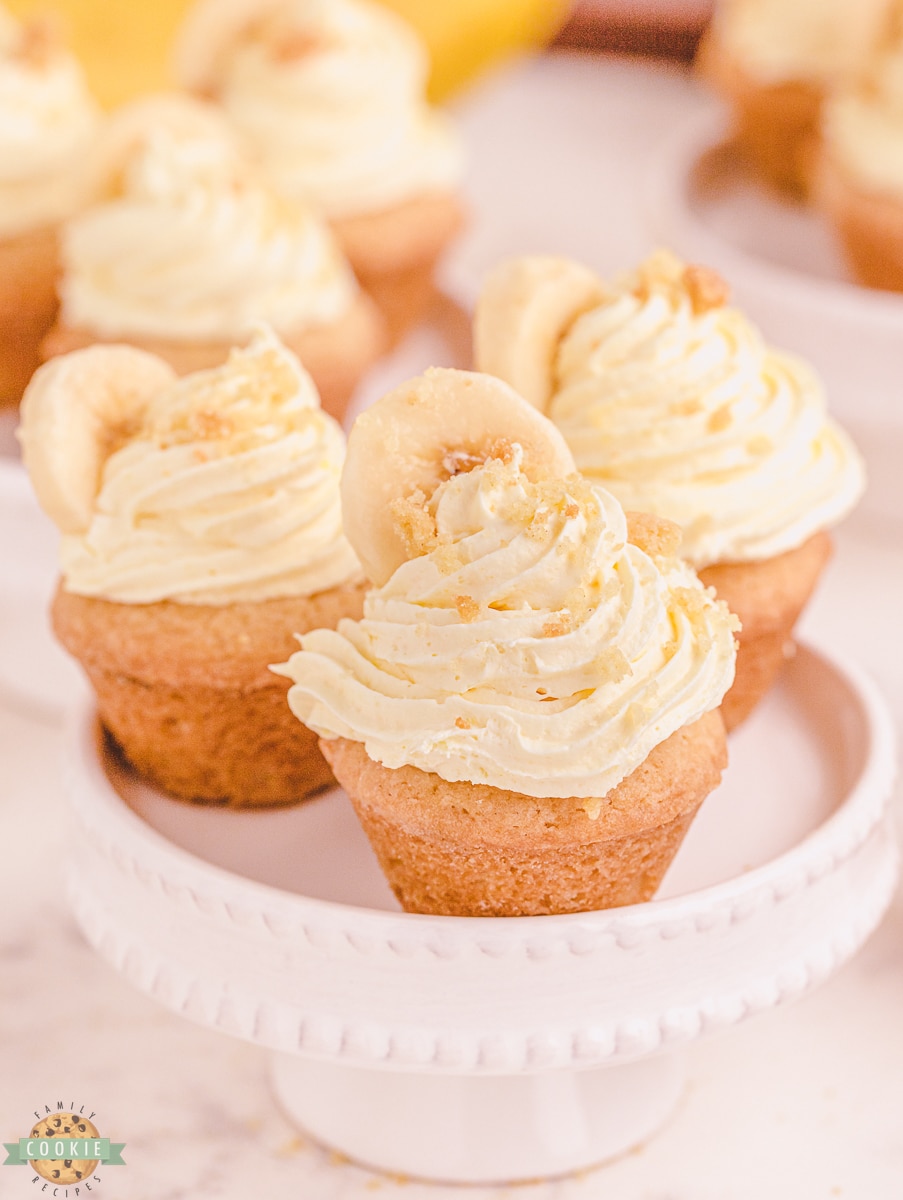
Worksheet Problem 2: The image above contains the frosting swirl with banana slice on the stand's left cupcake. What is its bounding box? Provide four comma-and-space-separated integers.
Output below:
20, 330, 359, 605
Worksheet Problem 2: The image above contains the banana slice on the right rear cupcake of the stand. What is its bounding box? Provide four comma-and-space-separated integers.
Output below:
473, 254, 605, 412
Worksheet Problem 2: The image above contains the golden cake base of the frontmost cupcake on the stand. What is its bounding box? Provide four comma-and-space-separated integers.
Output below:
321, 709, 728, 917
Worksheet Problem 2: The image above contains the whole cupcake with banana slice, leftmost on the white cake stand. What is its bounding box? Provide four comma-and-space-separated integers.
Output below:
19, 331, 361, 805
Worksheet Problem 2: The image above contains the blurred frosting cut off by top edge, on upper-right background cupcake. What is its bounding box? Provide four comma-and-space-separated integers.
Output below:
713, 0, 889, 85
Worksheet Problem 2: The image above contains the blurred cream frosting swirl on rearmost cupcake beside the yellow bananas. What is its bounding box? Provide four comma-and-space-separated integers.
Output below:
211, 0, 461, 220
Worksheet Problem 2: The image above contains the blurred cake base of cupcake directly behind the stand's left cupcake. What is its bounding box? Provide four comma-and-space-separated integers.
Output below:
41, 293, 388, 421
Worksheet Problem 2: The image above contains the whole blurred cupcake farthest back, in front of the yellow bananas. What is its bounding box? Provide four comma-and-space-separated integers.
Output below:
177, 0, 464, 336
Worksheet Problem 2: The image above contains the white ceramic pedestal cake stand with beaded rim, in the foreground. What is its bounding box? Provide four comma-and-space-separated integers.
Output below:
66, 648, 897, 1183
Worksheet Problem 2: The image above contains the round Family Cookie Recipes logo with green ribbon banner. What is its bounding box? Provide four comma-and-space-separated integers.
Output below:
2, 1100, 125, 1200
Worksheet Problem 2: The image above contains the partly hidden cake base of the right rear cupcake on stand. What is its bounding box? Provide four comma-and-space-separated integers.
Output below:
699, 530, 833, 731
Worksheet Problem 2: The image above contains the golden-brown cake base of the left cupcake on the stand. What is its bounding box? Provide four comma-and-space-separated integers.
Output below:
52, 584, 364, 808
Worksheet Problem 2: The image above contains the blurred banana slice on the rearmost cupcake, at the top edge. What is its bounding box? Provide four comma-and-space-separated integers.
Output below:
173, 0, 285, 95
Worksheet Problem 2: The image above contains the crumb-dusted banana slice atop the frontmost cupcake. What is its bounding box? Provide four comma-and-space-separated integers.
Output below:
341, 367, 576, 587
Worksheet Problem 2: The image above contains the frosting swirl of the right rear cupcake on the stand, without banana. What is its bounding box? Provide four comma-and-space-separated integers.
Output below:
549, 258, 865, 569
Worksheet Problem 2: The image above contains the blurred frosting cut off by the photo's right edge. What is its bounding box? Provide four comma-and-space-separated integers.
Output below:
824, 44, 903, 200
